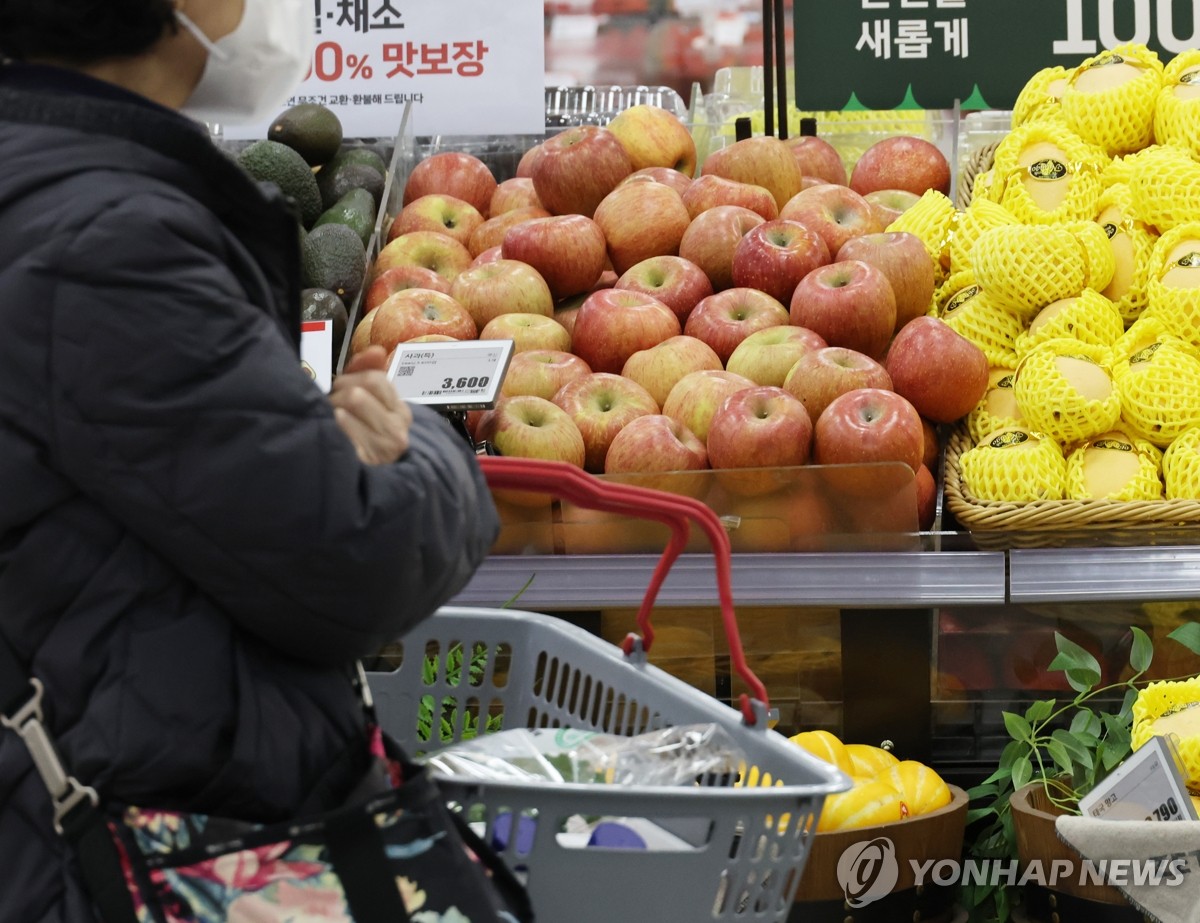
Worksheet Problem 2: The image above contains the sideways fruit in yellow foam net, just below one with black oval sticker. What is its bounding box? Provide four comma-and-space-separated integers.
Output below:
971, 224, 1108, 323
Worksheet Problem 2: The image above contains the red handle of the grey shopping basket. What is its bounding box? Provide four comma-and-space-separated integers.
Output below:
479, 455, 770, 725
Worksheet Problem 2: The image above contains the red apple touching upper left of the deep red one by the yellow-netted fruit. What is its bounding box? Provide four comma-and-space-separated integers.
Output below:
791, 261, 896, 359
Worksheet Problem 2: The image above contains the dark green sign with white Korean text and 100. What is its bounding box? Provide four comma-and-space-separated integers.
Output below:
793, 0, 1200, 110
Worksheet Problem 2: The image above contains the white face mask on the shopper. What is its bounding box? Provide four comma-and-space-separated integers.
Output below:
175, 0, 314, 124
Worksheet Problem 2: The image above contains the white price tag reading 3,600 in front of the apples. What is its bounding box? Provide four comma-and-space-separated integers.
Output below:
388, 340, 514, 410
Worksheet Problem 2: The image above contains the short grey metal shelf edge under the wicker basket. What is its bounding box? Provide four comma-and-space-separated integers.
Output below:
1008, 546, 1200, 604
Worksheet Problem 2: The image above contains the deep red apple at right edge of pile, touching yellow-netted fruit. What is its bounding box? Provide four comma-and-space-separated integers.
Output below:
883, 317, 988, 422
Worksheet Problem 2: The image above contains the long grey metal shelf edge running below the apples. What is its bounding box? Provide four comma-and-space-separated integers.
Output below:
455, 551, 1006, 610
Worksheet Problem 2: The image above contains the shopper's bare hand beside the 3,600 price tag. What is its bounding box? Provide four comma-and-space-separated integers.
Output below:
329, 346, 413, 465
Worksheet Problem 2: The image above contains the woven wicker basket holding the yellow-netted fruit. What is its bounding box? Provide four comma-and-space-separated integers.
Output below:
943, 427, 1200, 549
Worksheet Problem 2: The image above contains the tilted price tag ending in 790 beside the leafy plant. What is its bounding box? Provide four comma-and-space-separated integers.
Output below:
1079, 737, 1196, 821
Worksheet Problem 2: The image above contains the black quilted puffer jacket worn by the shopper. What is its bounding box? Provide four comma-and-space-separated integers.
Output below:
0, 67, 497, 923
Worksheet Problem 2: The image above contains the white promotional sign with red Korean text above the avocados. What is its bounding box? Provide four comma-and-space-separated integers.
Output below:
222, 0, 546, 139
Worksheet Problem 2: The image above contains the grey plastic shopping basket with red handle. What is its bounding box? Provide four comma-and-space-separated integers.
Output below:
368, 458, 850, 923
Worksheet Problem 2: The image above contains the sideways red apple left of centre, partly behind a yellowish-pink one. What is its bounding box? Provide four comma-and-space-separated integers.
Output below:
500, 212, 608, 300
